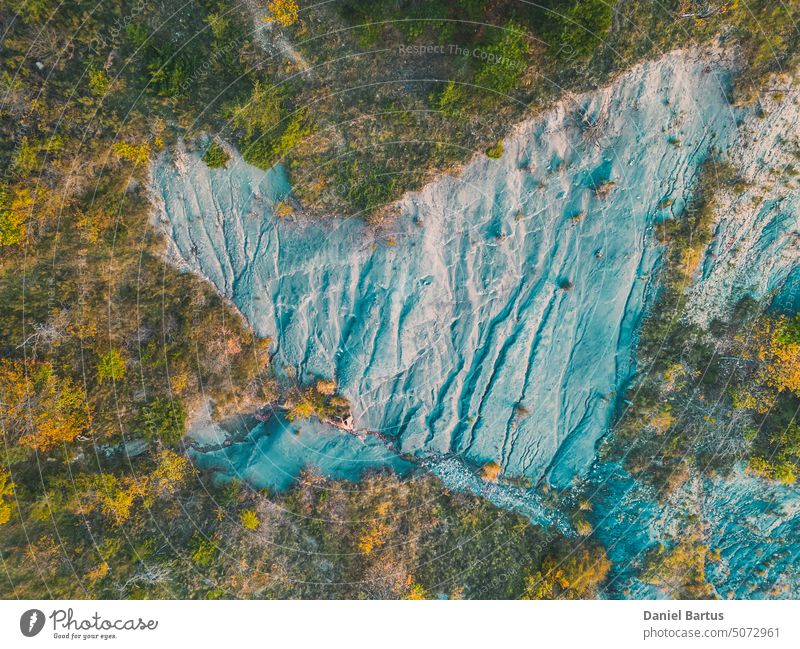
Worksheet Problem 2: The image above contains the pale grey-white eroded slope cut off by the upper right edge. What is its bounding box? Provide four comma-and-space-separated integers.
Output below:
688, 78, 800, 324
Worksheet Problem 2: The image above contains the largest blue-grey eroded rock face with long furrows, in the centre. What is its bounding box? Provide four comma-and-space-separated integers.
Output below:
153, 46, 789, 485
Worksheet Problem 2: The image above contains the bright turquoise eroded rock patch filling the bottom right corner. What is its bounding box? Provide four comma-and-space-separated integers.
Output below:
590, 463, 800, 599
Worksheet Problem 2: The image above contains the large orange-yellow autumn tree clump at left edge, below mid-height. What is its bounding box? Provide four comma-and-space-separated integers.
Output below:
0, 359, 90, 452
